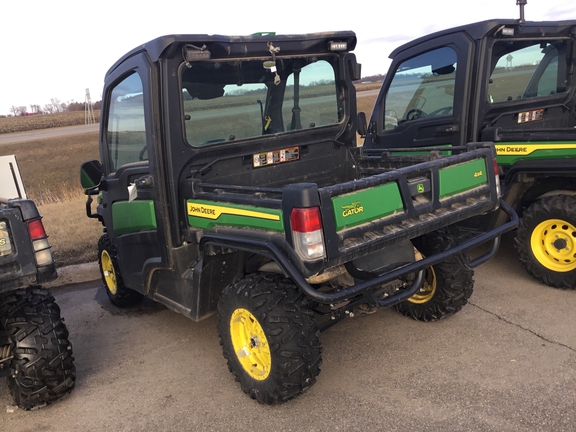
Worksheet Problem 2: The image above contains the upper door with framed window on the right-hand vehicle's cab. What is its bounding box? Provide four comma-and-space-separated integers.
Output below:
364, 34, 473, 148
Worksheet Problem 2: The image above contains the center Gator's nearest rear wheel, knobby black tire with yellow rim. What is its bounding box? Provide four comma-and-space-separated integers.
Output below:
218, 273, 322, 405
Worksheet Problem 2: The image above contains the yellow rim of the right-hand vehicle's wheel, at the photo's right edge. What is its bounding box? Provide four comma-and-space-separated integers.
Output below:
530, 219, 576, 273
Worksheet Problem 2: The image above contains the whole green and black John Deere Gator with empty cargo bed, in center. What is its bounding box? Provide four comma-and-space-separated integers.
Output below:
81, 31, 517, 404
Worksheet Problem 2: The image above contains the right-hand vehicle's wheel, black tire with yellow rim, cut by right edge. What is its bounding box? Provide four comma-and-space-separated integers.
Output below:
514, 195, 576, 289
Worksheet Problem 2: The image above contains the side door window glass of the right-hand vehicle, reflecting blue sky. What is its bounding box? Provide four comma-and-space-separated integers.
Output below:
383, 47, 457, 130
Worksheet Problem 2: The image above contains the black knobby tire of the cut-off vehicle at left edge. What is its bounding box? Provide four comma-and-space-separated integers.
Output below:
0, 286, 76, 410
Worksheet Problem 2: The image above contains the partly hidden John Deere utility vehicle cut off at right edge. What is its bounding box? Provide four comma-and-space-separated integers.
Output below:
364, 13, 576, 288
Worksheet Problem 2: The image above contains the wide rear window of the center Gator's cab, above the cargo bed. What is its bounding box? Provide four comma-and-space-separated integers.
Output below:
181, 55, 344, 146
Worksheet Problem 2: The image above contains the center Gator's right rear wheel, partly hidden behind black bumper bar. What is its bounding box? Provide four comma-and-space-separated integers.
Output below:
395, 229, 474, 321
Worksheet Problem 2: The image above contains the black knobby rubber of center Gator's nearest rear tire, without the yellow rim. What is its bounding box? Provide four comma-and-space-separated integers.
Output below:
218, 273, 322, 405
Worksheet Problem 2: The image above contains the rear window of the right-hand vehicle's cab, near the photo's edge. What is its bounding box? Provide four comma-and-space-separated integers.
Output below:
488, 41, 566, 103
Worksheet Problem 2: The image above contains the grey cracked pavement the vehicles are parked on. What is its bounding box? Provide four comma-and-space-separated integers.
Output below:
0, 237, 576, 432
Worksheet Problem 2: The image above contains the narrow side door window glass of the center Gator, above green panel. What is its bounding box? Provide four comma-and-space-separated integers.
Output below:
107, 73, 148, 172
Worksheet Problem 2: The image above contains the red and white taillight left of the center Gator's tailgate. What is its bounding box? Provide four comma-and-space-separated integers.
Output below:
290, 207, 326, 261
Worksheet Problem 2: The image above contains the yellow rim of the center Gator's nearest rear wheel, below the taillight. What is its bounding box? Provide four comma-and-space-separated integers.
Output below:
230, 308, 272, 381
